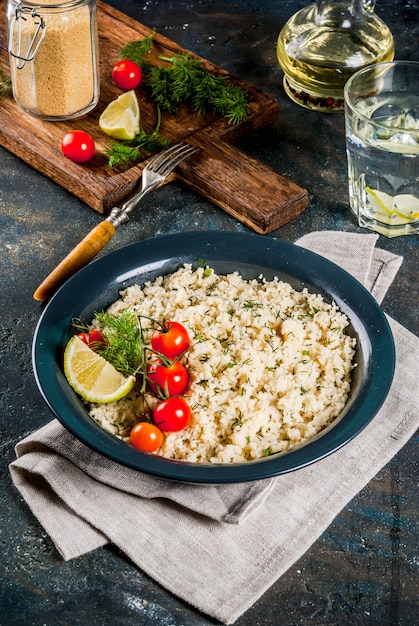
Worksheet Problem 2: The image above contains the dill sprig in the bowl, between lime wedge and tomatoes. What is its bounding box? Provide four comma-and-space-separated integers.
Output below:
95, 309, 147, 381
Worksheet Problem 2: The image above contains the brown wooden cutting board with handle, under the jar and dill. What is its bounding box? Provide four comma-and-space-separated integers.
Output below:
0, 1, 308, 234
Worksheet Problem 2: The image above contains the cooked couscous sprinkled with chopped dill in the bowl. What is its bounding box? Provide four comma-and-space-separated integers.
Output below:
89, 265, 356, 463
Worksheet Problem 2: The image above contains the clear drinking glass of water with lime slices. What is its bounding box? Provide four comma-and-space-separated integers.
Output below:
344, 61, 419, 237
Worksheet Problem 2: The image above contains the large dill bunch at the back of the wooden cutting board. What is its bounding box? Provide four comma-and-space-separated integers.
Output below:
121, 32, 249, 124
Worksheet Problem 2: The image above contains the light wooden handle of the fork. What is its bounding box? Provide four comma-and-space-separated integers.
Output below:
33, 220, 116, 302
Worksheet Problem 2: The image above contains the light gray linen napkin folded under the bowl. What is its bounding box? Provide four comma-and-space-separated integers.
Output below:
10, 232, 419, 624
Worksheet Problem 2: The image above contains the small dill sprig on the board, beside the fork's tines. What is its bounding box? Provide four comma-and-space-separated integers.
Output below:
107, 107, 169, 167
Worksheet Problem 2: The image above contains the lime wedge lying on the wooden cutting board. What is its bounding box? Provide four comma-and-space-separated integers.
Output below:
99, 90, 140, 139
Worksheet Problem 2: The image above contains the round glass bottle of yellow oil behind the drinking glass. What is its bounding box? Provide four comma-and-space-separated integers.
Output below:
277, 0, 394, 111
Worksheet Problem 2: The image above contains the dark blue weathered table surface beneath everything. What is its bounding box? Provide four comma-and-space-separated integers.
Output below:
0, 0, 419, 626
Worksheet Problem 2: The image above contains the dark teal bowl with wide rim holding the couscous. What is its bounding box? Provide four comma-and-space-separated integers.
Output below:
33, 232, 395, 484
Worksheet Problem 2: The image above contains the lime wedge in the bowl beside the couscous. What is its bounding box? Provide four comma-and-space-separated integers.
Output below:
64, 335, 135, 403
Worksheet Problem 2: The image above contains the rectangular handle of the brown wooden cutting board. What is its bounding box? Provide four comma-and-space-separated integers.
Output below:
176, 132, 308, 234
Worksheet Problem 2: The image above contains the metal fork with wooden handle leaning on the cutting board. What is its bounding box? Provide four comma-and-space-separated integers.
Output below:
33, 143, 198, 301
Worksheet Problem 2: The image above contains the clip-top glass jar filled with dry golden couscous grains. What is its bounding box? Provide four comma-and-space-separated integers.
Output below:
7, 0, 99, 121
